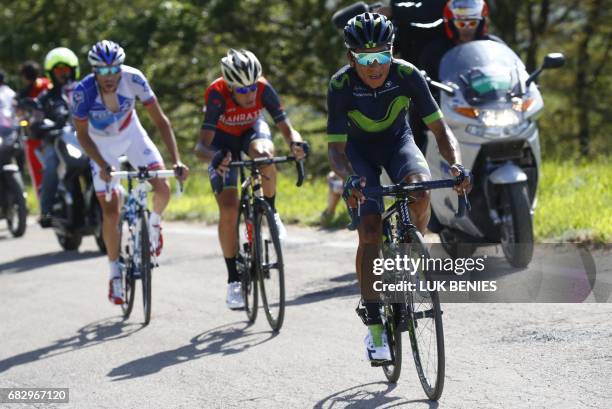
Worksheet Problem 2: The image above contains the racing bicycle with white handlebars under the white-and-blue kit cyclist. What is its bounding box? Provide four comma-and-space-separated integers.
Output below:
106, 167, 183, 325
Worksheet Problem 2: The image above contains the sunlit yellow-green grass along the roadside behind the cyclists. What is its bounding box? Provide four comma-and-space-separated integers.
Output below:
22, 157, 612, 244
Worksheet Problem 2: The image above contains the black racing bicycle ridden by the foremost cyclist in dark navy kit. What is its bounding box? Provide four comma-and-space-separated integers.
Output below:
349, 176, 469, 401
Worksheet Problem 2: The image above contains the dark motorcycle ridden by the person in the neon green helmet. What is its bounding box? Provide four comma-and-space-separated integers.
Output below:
29, 100, 106, 253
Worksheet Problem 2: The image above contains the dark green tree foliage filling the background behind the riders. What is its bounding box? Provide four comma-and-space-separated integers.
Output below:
0, 0, 612, 158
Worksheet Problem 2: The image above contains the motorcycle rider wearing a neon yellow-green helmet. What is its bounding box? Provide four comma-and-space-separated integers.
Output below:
31, 47, 80, 227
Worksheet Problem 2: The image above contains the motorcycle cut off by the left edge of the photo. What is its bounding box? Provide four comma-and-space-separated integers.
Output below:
0, 117, 28, 237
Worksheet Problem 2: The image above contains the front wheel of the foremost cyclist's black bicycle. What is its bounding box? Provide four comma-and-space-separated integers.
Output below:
404, 229, 445, 401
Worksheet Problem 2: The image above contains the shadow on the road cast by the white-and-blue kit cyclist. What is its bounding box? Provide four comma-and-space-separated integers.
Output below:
0, 317, 143, 373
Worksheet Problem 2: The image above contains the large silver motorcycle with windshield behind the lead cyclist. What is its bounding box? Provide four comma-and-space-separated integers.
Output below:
426, 40, 565, 267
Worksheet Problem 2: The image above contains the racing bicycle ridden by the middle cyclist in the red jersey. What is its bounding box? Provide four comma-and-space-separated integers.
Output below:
229, 156, 304, 331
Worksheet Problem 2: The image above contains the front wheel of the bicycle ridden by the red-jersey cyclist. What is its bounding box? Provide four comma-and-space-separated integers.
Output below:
255, 200, 285, 331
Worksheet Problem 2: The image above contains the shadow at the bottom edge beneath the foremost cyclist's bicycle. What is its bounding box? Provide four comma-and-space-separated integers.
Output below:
313, 382, 438, 409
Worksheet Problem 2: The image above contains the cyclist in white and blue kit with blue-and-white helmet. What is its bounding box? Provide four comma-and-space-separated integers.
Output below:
72, 40, 189, 304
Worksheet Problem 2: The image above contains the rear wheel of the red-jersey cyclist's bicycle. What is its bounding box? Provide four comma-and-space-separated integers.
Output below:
236, 201, 259, 322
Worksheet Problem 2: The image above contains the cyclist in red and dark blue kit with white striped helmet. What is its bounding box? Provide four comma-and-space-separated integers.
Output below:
195, 49, 307, 309
